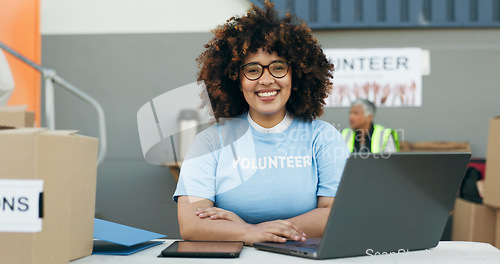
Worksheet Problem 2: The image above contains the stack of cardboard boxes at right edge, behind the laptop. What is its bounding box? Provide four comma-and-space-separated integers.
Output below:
452, 117, 500, 248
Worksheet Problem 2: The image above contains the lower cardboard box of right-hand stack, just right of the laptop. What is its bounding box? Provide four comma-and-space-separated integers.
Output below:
451, 198, 496, 245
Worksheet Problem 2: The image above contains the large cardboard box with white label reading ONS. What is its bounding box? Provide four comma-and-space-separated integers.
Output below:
0, 128, 98, 264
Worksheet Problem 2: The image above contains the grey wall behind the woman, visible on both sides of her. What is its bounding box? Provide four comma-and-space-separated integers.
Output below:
42, 29, 500, 238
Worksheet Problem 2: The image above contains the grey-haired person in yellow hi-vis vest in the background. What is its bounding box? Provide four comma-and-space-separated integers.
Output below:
342, 99, 399, 153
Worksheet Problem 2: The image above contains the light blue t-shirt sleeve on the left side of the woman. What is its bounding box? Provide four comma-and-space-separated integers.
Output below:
173, 128, 218, 202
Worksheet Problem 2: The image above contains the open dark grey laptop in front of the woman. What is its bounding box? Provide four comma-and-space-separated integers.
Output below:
254, 152, 471, 259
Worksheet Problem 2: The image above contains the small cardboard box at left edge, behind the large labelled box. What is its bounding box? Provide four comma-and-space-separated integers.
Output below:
0, 106, 35, 127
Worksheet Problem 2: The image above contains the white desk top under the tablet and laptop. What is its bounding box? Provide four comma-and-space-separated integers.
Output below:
70, 240, 500, 264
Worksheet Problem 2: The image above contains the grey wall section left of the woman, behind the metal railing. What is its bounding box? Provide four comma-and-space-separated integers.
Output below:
42, 33, 210, 238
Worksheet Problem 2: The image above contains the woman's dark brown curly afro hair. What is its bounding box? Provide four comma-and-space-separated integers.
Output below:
197, 1, 333, 121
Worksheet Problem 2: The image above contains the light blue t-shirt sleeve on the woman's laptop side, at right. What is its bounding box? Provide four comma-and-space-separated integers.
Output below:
314, 124, 349, 197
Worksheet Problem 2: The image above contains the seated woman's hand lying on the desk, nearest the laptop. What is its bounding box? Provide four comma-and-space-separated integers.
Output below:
244, 220, 306, 246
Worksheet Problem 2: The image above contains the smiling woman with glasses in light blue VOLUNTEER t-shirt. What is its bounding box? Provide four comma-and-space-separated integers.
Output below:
174, 2, 349, 245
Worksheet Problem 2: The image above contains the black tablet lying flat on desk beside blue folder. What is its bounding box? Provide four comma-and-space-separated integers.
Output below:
158, 241, 243, 258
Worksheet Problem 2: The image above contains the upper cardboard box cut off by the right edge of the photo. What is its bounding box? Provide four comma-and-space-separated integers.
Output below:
483, 117, 500, 208
